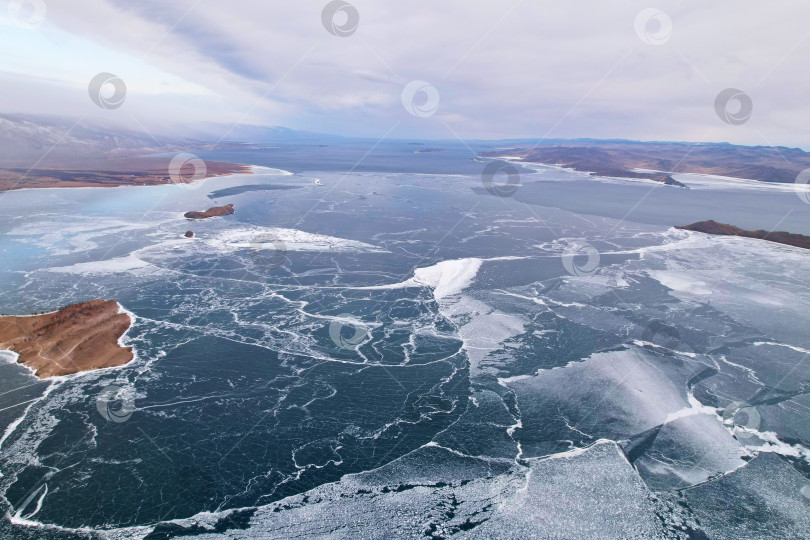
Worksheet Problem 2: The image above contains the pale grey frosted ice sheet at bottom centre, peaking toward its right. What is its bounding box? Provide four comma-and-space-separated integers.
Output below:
167, 441, 665, 540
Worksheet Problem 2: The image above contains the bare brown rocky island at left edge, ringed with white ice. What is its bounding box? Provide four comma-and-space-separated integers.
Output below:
0, 300, 134, 379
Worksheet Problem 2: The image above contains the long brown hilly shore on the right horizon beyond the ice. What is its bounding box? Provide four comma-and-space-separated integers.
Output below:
482, 139, 810, 183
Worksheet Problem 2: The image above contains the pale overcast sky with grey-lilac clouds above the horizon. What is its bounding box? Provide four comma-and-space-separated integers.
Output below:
0, 0, 810, 149
